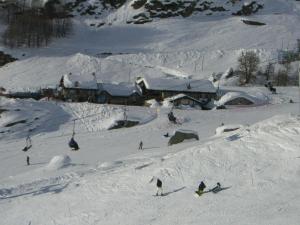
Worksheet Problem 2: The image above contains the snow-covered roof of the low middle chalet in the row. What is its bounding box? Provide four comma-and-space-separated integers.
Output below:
99, 83, 140, 96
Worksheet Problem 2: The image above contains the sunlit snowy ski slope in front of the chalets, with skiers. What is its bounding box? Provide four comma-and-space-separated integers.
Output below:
0, 85, 300, 225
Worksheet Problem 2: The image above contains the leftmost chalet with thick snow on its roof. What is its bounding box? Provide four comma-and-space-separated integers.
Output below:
59, 73, 98, 102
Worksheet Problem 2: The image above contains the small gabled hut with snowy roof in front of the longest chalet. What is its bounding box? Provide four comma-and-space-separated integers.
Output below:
164, 94, 203, 108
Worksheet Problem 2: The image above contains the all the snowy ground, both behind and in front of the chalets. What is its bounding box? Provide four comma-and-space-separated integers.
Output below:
0, 0, 300, 225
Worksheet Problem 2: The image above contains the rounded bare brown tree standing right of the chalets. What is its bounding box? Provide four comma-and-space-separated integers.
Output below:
238, 51, 260, 84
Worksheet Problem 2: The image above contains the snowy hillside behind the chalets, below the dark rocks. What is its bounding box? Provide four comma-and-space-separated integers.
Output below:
0, 0, 300, 89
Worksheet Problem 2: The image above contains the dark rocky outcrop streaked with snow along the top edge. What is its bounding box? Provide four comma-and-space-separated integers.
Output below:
66, 0, 263, 24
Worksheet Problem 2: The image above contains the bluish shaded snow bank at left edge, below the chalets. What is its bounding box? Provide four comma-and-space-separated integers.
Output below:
0, 97, 68, 139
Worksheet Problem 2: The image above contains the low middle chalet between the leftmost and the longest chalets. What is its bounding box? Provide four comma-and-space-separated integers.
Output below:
96, 83, 144, 105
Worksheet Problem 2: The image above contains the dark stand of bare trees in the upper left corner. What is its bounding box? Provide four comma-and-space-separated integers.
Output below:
0, 1, 72, 48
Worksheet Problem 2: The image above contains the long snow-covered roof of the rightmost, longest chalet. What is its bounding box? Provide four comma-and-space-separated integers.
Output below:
136, 77, 216, 93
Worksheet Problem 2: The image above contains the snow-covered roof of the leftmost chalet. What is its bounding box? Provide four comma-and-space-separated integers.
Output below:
63, 73, 98, 89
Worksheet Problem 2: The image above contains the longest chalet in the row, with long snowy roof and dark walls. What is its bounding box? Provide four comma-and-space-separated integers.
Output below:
136, 77, 216, 101
